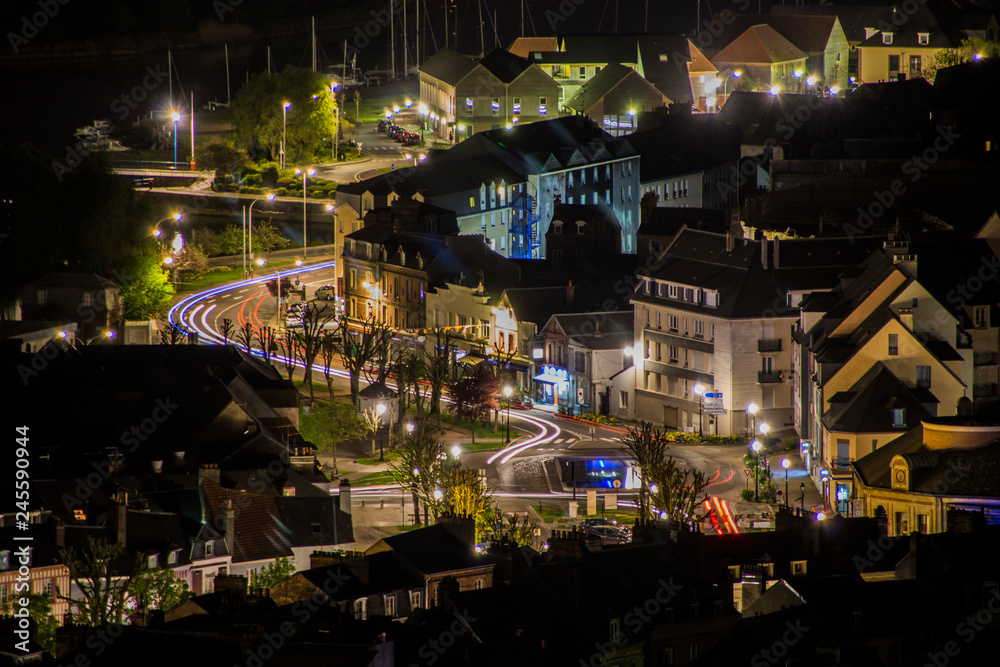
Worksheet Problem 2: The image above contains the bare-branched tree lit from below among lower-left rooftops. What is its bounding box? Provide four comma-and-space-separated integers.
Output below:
57, 537, 146, 627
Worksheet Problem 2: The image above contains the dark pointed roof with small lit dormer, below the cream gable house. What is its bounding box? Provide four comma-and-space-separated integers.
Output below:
823, 361, 937, 433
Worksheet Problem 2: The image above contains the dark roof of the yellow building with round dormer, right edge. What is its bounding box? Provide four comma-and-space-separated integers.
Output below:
851, 418, 1000, 498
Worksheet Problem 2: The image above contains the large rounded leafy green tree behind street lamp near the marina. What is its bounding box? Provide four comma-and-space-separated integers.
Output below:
233, 66, 337, 163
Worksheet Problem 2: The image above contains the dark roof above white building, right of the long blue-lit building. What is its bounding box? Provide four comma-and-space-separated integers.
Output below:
630, 112, 740, 183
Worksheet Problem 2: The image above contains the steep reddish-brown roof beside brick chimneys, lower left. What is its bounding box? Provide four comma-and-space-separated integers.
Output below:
202, 480, 292, 563
